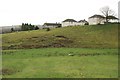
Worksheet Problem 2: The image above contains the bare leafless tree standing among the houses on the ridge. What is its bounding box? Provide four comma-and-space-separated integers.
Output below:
100, 6, 115, 23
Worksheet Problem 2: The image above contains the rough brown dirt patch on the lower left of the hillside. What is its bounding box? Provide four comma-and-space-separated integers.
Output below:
3, 35, 74, 49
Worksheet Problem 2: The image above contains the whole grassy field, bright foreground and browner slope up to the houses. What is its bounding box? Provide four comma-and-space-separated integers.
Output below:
0, 24, 119, 78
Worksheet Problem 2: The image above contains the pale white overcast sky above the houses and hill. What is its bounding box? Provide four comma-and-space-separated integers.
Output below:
0, 0, 120, 26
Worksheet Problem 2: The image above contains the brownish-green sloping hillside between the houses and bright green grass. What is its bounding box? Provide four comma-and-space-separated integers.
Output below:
2, 24, 118, 49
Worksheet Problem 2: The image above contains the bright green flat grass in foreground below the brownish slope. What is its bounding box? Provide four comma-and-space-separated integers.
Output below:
3, 48, 118, 78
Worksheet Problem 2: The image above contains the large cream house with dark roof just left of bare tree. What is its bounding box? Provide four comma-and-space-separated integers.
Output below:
88, 14, 105, 25
